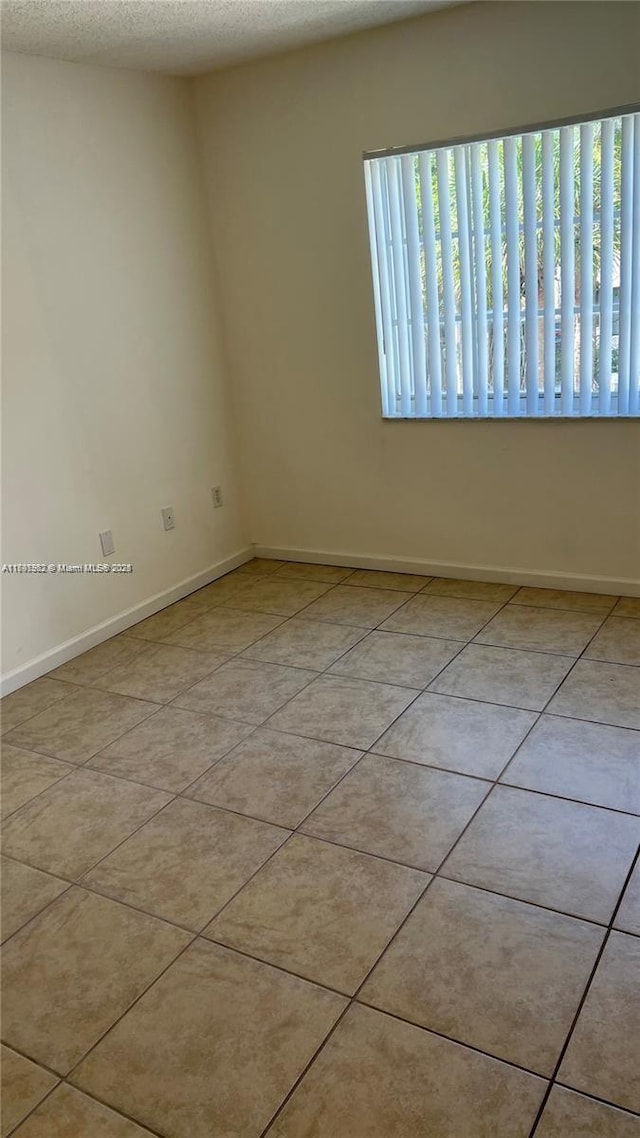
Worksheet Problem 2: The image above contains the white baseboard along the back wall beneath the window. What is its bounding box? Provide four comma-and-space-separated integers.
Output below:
254, 544, 640, 596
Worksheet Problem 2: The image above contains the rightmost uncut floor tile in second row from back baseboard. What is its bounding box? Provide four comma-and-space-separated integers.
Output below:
476, 604, 602, 655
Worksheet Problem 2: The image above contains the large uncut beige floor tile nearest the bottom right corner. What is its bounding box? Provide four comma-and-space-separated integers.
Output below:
360, 879, 605, 1075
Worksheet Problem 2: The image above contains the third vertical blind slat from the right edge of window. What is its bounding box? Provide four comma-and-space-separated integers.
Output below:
598, 119, 614, 415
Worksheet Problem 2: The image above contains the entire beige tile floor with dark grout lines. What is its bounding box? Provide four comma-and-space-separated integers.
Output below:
1, 559, 640, 1138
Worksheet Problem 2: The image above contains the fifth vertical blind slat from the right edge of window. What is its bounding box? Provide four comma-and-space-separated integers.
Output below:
560, 126, 575, 415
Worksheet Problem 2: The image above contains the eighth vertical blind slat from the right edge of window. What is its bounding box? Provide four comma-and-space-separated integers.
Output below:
504, 138, 522, 415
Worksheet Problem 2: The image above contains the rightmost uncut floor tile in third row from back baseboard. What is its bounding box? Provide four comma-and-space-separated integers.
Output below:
430, 644, 575, 711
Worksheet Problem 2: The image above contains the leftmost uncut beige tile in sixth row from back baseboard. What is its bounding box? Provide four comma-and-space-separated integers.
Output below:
83, 799, 288, 931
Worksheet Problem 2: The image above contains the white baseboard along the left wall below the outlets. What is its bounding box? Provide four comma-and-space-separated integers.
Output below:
0, 546, 254, 695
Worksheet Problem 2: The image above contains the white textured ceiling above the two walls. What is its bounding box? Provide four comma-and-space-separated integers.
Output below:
0, 0, 461, 75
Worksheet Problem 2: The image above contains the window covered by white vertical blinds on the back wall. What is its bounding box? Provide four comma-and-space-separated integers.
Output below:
364, 108, 640, 419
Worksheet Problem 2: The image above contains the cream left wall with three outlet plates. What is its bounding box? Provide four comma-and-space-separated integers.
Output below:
1, 55, 248, 673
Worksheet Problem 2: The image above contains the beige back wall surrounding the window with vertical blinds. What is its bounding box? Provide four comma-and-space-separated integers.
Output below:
197, 2, 640, 579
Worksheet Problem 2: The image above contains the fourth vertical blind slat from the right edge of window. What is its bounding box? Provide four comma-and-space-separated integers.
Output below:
580, 123, 593, 415
